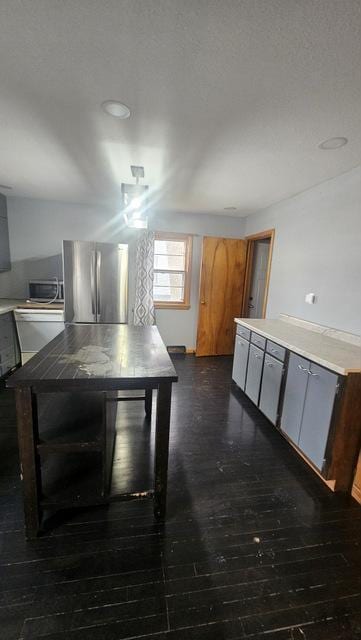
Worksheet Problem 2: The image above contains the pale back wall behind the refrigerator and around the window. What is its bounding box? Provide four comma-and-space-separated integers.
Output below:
0, 197, 244, 348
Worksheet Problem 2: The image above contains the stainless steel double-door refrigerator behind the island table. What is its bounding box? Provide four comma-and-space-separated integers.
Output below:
63, 240, 128, 323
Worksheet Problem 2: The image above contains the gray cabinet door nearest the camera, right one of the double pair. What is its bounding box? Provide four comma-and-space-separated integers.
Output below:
298, 363, 338, 470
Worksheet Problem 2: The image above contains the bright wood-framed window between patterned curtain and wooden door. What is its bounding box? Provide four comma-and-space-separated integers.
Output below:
153, 233, 192, 309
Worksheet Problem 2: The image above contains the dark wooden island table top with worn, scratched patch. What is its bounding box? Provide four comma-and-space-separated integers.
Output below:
6, 324, 178, 391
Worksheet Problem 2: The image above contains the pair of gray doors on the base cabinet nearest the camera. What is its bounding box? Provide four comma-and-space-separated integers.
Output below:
281, 353, 338, 471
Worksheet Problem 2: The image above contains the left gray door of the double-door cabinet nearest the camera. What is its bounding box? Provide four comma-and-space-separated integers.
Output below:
281, 353, 310, 444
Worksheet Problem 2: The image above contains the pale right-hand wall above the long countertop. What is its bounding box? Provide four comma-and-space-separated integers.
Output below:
245, 167, 361, 334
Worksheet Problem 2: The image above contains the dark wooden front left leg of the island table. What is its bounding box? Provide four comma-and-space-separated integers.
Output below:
16, 387, 41, 538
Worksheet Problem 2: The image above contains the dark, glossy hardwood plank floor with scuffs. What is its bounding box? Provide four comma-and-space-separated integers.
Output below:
0, 356, 361, 640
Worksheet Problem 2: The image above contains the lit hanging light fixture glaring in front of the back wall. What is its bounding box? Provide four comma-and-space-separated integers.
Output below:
122, 165, 148, 229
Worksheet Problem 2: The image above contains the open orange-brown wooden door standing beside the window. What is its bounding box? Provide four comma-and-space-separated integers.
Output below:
196, 237, 247, 356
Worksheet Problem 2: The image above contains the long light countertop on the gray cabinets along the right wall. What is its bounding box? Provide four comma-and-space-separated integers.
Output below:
234, 318, 361, 375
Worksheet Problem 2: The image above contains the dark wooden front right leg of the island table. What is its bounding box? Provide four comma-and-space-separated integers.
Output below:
154, 382, 172, 519
